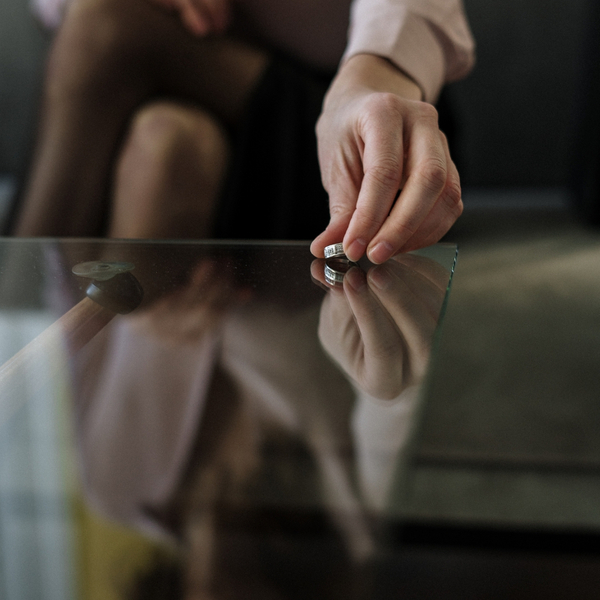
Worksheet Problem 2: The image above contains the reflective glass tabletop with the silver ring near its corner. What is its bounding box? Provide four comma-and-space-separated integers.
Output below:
0, 239, 457, 600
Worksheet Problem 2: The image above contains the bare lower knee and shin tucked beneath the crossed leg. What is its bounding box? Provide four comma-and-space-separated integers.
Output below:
109, 102, 229, 239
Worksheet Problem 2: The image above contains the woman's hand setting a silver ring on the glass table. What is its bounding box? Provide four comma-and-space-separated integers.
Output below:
311, 54, 462, 264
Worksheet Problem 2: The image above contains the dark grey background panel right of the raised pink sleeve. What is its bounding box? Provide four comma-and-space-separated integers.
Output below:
447, 0, 597, 187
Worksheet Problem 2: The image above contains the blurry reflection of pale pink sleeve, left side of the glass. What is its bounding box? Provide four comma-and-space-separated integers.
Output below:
76, 318, 218, 537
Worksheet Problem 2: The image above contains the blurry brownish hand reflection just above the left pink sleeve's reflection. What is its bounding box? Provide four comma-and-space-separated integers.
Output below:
131, 259, 251, 342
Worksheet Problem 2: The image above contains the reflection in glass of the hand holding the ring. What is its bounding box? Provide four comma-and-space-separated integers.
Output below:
311, 254, 448, 399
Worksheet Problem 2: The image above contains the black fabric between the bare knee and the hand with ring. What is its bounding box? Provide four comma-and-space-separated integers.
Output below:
216, 57, 331, 240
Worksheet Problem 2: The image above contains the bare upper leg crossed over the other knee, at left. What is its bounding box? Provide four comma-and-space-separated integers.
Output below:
16, 0, 268, 236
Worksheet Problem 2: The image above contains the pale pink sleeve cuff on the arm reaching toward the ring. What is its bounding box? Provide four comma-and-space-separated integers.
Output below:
342, 0, 475, 102
